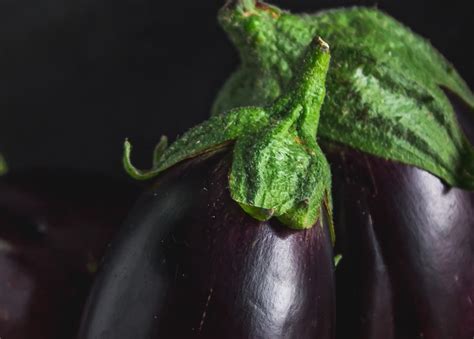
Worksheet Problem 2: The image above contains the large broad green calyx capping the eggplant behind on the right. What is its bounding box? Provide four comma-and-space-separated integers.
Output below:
213, 0, 474, 190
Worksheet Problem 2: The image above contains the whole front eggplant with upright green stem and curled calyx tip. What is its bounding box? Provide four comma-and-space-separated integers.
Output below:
79, 37, 335, 339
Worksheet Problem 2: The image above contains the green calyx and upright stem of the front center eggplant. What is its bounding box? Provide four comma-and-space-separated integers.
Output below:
123, 38, 332, 234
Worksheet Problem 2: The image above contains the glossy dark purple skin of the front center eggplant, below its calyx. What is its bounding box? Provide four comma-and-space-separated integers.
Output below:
79, 154, 335, 339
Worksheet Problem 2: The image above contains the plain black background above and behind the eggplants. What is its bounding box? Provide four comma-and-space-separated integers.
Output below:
0, 0, 474, 179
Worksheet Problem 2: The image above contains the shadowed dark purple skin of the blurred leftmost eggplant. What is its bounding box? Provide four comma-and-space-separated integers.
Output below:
0, 171, 138, 339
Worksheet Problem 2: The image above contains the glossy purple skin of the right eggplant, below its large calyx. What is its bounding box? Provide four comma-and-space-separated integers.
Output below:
325, 143, 474, 339
